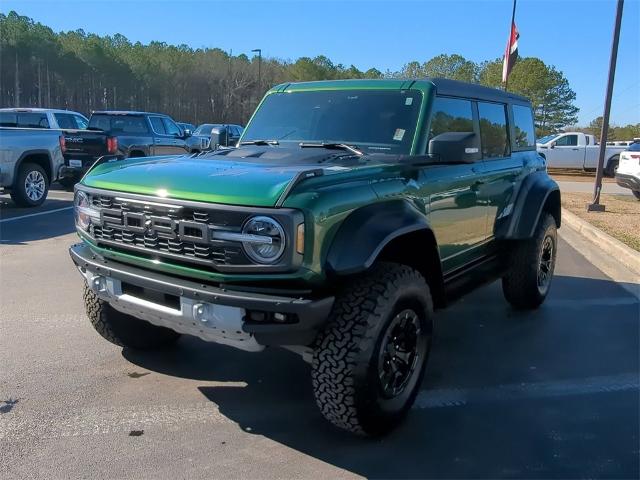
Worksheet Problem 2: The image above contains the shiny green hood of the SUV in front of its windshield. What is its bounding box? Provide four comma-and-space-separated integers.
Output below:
82, 147, 368, 207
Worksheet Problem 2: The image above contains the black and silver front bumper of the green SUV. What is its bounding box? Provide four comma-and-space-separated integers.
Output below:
69, 243, 334, 351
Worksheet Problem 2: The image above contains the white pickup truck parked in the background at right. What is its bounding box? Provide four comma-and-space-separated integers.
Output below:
537, 132, 627, 177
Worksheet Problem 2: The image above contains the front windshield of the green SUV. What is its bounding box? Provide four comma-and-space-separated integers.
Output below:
242, 90, 422, 153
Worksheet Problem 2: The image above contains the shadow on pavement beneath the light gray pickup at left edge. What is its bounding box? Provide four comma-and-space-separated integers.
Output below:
0, 199, 75, 245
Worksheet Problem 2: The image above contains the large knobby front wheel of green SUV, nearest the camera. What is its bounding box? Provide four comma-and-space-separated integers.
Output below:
311, 263, 433, 435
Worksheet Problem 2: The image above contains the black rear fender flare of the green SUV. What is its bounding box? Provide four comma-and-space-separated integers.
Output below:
495, 171, 561, 240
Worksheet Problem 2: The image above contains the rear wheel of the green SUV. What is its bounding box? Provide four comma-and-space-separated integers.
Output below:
502, 213, 558, 309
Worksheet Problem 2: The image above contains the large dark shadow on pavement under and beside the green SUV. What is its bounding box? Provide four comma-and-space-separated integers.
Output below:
123, 276, 640, 478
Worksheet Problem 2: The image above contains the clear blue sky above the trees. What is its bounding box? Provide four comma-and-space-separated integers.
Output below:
0, 0, 640, 125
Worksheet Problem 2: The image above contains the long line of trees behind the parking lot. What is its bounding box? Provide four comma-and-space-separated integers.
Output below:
0, 11, 632, 138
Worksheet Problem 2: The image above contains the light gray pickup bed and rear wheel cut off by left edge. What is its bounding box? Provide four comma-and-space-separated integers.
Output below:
0, 127, 64, 207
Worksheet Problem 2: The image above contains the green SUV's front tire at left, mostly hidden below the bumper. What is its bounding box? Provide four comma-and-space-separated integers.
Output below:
84, 284, 180, 350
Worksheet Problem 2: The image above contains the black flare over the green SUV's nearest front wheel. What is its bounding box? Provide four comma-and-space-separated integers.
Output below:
326, 200, 430, 275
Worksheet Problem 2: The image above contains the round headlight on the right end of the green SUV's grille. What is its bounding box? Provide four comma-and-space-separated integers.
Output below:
242, 217, 286, 264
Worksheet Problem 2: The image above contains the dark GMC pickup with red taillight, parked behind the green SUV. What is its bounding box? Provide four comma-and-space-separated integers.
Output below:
60, 111, 199, 188
